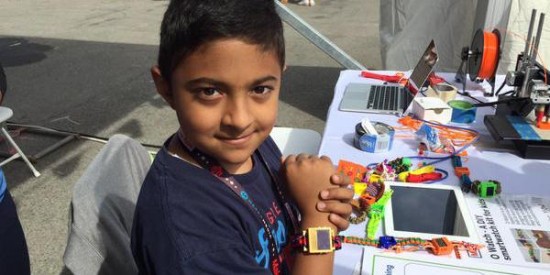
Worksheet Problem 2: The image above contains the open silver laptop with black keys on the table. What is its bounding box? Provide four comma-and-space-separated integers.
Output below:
339, 40, 439, 115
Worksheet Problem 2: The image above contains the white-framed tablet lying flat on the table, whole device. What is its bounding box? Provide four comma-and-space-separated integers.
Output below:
384, 181, 478, 243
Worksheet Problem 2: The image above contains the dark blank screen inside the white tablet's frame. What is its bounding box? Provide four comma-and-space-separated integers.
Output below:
391, 186, 469, 237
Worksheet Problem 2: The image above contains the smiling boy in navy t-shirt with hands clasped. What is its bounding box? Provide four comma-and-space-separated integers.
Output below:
132, 0, 353, 274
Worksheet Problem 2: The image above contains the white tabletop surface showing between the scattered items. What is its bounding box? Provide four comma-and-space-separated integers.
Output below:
326, 70, 550, 274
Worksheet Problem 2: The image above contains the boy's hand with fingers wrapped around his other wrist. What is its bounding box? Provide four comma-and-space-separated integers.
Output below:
317, 174, 354, 231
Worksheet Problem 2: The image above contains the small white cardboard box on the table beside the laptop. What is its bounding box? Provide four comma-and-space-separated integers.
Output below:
412, 97, 452, 124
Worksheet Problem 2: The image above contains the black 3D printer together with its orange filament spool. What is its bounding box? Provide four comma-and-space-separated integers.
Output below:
457, 10, 550, 159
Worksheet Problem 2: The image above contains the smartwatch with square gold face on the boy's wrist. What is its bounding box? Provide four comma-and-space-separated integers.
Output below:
292, 227, 342, 254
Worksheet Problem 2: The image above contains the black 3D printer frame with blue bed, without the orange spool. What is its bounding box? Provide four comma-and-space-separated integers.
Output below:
483, 10, 550, 159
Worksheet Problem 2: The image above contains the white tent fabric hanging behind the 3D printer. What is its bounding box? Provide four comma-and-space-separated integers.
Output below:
380, 0, 550, 74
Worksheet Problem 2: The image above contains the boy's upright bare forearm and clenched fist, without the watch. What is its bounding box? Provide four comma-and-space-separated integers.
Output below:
281, 154, 337, 274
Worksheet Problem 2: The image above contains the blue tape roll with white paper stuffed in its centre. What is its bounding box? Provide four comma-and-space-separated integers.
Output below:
354, 121, 395, 153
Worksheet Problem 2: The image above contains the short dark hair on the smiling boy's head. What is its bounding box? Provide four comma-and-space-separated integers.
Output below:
158, 0, 285, 83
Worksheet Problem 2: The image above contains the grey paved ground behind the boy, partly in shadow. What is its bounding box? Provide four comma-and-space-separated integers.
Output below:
0, 0, 381, 274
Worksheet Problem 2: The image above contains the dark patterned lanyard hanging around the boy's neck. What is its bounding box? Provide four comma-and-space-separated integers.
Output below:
177, 132, 299, 274
